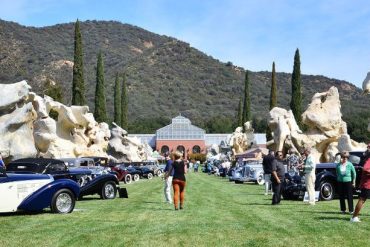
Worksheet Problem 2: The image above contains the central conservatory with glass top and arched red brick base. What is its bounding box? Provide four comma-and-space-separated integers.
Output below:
156, 115, 206, 158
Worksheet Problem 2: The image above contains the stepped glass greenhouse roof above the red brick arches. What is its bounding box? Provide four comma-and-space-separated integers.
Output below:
156, 116, 205, 140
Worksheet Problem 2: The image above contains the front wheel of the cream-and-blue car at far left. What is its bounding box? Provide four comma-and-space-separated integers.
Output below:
50, 189, 76, 214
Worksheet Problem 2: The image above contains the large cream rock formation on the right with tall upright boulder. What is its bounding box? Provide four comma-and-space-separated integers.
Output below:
269, 87, 366, 162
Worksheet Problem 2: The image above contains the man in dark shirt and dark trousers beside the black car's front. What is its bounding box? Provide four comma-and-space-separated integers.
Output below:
271, 151, 285, 205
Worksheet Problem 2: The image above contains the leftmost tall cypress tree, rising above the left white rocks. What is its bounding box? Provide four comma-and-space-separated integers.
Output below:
72, 19, 86, 105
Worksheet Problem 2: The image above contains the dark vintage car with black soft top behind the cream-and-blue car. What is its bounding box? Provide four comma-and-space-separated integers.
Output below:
7, 158, 121, 199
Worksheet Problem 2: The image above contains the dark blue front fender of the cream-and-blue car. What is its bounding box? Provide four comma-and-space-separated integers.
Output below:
18, 179, 80, 212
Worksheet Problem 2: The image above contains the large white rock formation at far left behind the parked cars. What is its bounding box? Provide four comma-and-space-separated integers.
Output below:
0, 81, 110, 161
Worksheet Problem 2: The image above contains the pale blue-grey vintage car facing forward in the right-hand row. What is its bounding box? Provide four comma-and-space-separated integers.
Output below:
232, 158, 265, 185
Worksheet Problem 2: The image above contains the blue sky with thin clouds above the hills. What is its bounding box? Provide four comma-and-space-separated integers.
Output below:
0, 0, 370, 87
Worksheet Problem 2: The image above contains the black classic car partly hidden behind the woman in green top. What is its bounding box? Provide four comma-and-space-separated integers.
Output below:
282, 151, 364, 201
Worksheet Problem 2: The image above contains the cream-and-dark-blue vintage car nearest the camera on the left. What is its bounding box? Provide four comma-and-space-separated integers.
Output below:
0, 167, 80, 214
